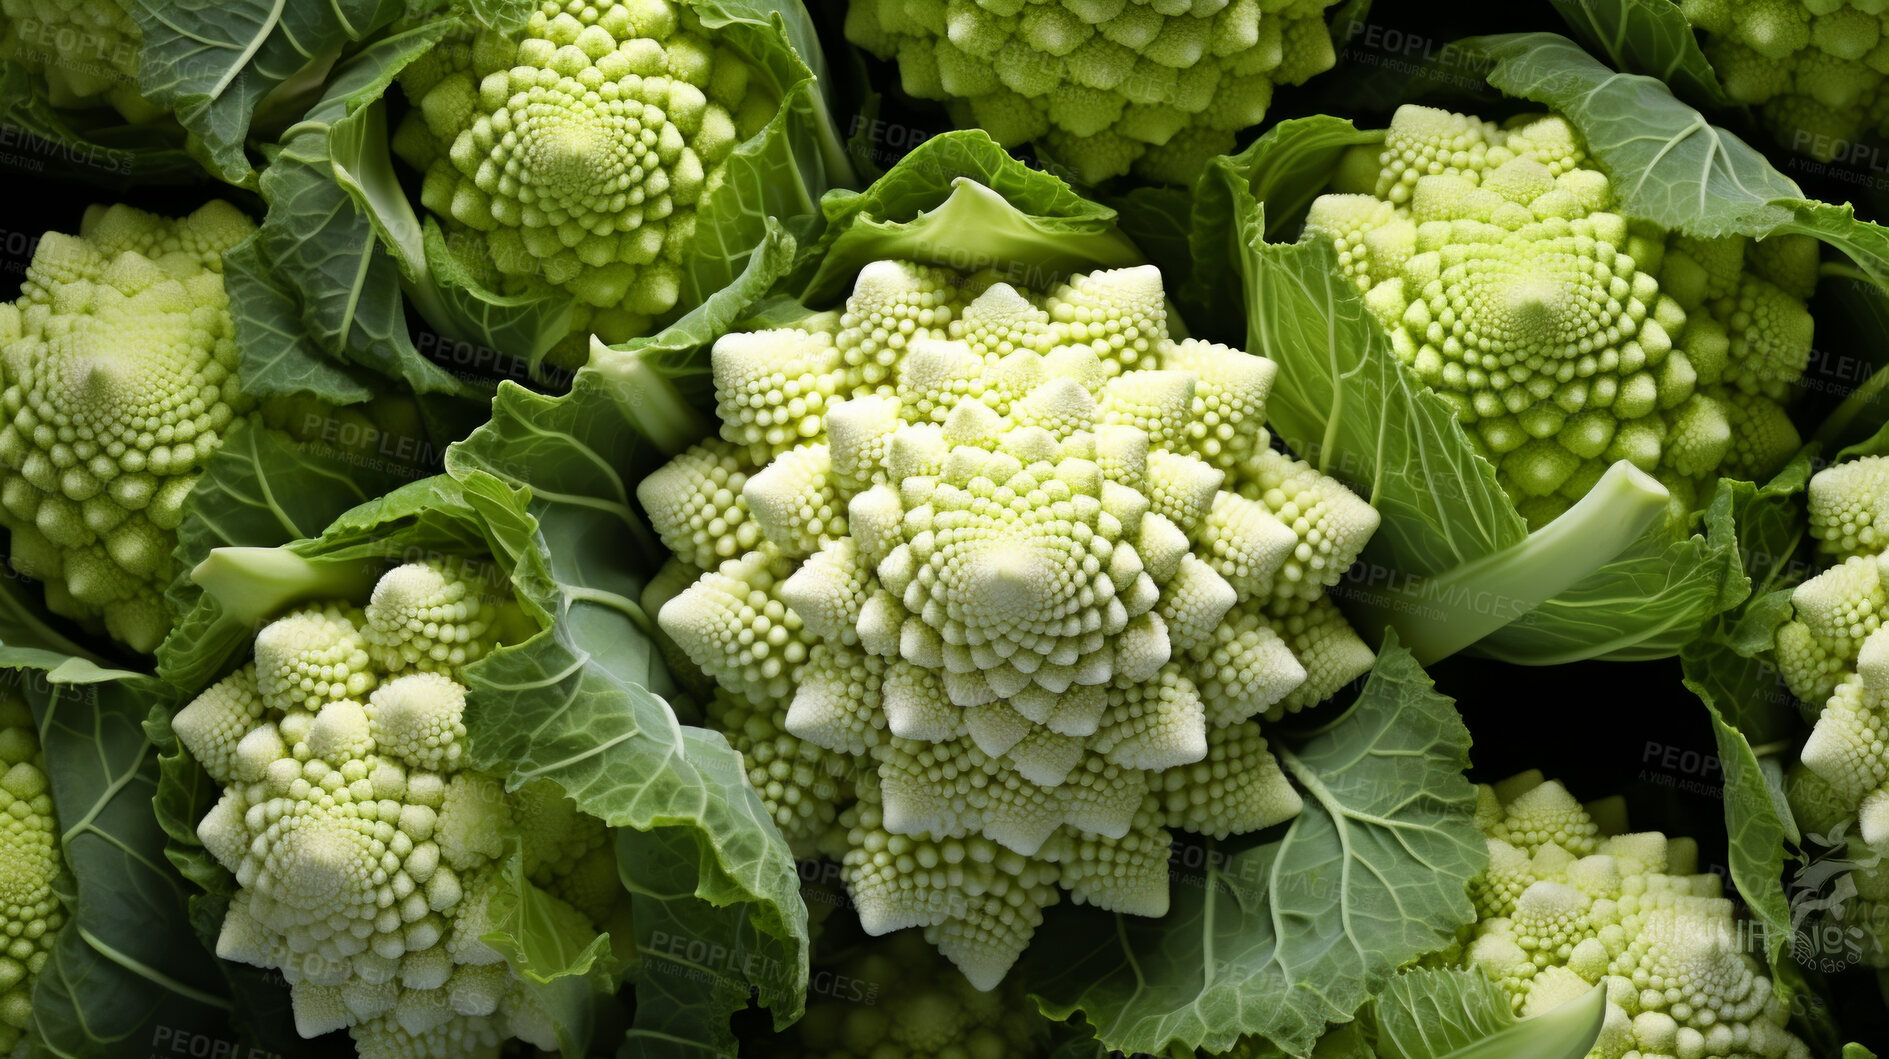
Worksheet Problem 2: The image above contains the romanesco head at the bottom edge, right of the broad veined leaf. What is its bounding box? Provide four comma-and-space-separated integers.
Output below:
1456, 772, 1810, 1059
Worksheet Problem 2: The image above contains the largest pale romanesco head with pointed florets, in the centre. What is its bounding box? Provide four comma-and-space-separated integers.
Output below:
638, 261, 1377, 989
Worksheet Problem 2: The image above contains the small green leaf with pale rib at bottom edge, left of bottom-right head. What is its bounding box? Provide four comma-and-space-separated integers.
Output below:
1370, 968, 1608, 1059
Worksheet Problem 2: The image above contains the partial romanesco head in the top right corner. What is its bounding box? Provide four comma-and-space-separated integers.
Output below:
1679, 0, 1889, 162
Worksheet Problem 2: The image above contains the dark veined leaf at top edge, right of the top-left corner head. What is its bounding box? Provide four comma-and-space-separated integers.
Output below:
130, 0, 406, 185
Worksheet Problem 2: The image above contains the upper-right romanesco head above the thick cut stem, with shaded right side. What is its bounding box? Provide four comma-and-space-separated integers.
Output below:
1305, 106, 1817, 527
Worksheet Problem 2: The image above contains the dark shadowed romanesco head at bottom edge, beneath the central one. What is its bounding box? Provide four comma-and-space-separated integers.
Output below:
795, 931, 1050, 1059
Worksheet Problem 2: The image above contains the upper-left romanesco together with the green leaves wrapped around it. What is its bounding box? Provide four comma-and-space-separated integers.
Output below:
238, 0, 850, 391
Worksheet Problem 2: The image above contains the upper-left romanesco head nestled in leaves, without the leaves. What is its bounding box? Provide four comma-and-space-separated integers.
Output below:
395, 0, 780, 362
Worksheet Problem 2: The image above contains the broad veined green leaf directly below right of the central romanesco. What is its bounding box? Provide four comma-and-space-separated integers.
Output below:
1018, 640, 1487, 1055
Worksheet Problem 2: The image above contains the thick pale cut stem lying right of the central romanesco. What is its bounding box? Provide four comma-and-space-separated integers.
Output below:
1354, 461, 1670, 664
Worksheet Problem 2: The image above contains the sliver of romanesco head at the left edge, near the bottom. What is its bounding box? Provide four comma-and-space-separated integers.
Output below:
0, 693, 66, 1055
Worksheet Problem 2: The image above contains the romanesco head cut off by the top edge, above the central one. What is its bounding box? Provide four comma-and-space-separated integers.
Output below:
846, 0, 1336, 183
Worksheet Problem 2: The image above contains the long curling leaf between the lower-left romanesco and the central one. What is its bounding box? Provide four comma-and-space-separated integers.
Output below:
448, 370, 808, 1042
